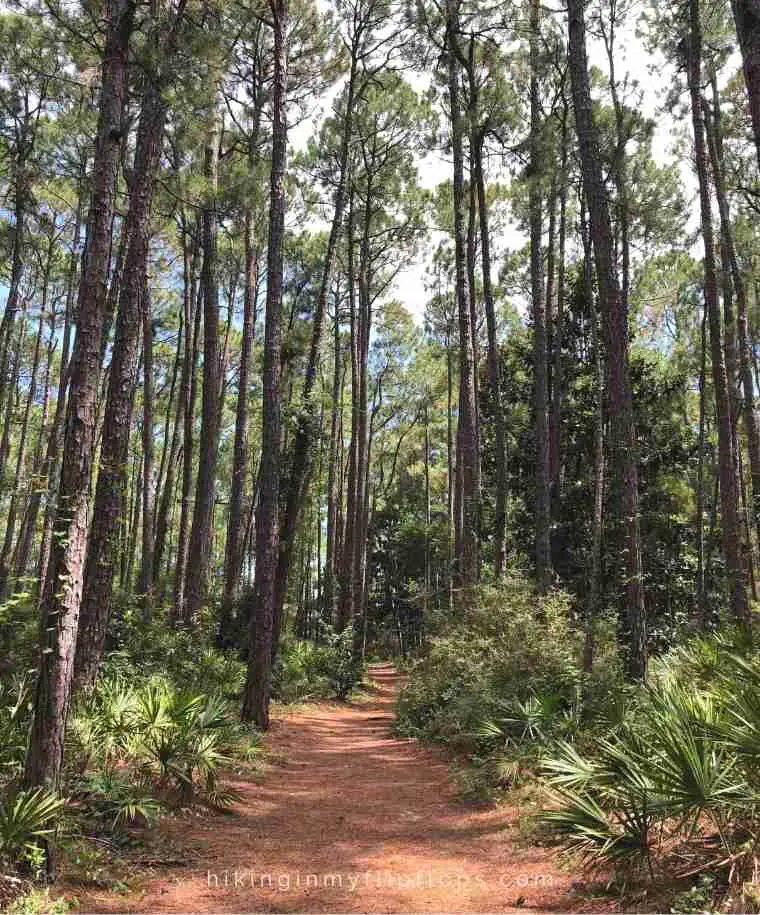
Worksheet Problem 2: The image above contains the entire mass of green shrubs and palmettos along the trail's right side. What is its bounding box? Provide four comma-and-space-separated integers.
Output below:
398, 578, 760, 912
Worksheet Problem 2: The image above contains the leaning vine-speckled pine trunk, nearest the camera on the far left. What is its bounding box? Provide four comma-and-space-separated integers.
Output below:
24, 0, 134, 860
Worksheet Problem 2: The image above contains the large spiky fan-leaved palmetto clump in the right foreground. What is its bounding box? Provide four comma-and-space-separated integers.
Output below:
543, 639, 760, 900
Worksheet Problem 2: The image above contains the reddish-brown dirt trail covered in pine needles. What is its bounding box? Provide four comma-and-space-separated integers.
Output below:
67, 665, 613, 913
